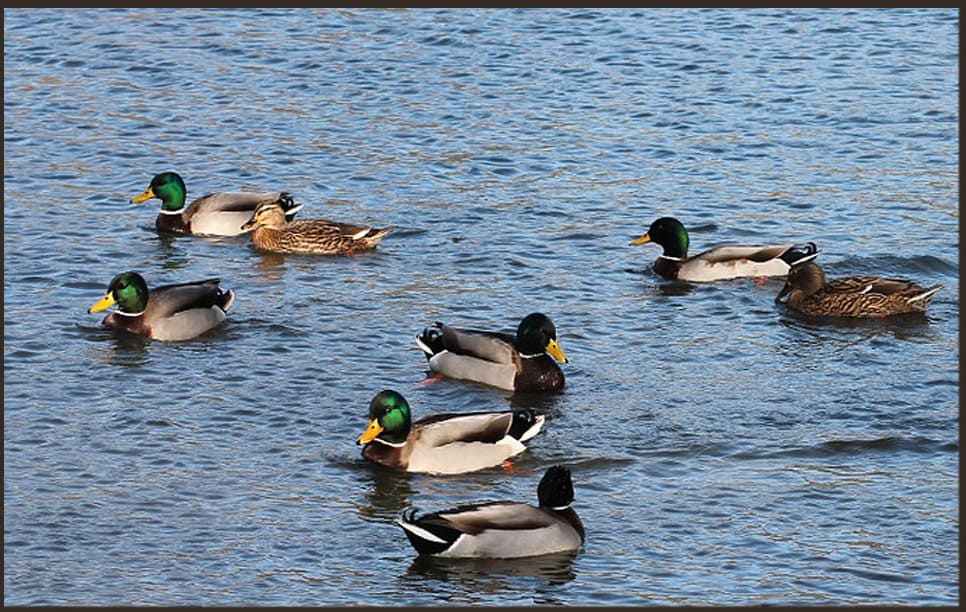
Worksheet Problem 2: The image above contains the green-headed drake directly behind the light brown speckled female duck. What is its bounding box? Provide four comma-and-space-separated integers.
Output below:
131, 172, 302, 236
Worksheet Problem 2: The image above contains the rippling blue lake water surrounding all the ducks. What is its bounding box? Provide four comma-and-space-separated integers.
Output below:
3, 9, 960, 606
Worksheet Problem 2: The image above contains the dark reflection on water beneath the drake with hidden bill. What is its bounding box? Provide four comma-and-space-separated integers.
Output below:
406, 552, 577, 593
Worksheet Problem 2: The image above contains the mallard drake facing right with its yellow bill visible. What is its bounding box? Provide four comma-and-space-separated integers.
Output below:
416, 312, 569, 392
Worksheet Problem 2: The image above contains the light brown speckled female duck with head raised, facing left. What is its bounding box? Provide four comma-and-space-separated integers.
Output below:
241, 202, 391, 255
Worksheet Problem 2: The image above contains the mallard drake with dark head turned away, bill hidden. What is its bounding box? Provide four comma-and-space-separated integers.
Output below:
396, 466, 586, 559
